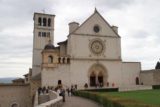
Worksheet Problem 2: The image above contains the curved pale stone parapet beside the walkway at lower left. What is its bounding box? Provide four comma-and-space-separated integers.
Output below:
34, 91, 63, 107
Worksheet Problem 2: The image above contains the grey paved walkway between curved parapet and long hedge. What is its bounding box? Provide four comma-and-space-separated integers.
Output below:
62, 96, 100, 107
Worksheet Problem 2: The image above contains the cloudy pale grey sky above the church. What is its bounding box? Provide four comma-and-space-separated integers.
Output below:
0, 0, 160, 77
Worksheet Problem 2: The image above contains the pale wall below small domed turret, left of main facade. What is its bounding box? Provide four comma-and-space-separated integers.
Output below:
41, 64, 71, 86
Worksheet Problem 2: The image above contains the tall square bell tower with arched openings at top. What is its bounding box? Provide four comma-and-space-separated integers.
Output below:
32, 13, 55, 76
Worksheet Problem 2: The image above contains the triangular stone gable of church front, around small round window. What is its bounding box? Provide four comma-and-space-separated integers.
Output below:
73, 11, 119, 37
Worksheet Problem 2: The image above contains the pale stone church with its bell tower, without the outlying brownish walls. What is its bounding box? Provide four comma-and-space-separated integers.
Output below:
32, 10, 141, 88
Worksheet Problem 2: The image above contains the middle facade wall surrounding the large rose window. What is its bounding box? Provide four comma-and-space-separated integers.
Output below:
68, 35, 121, 60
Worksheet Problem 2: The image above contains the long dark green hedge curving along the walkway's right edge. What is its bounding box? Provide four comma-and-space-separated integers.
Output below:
74, 91, 158, 107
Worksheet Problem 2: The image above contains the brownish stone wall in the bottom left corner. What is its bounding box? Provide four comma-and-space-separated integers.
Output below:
0, 84, 31, 107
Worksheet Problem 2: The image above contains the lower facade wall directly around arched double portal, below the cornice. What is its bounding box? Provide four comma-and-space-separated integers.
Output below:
70, 60, 122, 88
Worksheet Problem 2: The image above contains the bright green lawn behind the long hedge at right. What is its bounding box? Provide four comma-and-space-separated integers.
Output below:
99, 90, 160, 106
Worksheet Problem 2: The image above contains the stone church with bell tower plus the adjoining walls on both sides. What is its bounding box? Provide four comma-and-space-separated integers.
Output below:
0, 9, 160, 107
